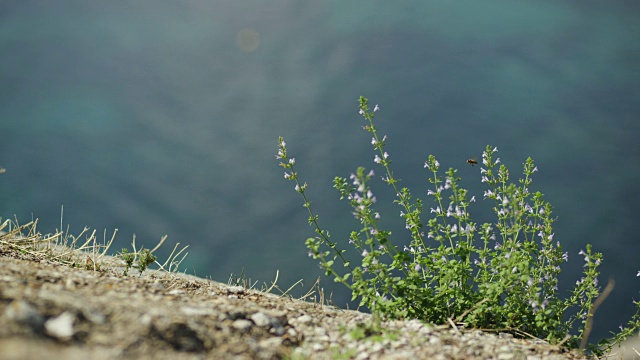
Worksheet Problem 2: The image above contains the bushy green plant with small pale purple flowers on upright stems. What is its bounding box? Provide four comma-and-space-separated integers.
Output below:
276, 97, 640, 353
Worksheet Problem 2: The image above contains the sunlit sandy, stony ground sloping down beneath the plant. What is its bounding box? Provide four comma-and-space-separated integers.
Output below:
0, 233, 592, 360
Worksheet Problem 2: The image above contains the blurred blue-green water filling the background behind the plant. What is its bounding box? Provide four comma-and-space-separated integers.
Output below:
0, 0, 640, 342
